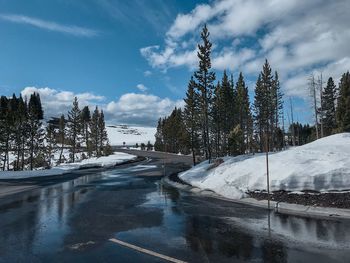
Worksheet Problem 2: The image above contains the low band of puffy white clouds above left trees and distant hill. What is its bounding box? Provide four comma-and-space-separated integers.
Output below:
21, 87, 183, 126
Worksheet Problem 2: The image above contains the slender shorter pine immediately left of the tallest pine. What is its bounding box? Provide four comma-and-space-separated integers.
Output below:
183, 77, 199, 165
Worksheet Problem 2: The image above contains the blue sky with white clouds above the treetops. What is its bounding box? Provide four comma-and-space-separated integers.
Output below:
0, 0, 350, 125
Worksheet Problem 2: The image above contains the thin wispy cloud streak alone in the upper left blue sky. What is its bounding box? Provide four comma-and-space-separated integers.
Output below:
0, 14, 98, 37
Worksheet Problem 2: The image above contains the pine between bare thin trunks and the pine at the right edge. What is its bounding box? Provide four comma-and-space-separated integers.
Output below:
322, 77, 336, 136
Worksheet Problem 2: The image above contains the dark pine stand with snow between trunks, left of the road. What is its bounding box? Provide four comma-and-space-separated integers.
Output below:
0, 93, 111, 170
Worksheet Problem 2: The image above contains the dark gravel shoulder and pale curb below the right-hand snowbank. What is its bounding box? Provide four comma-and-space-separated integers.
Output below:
162, 174, 350, 220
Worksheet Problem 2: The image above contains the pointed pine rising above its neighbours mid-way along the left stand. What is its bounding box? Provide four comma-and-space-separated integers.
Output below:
67, 97, 82, 163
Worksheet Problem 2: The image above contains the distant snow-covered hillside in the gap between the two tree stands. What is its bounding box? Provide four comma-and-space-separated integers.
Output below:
106, 125, 157, 146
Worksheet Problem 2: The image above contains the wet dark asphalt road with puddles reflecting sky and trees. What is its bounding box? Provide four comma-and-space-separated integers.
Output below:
0, 156, 350, 262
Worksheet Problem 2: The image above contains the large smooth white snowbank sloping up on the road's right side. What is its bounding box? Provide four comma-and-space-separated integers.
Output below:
179, 133, 350, 199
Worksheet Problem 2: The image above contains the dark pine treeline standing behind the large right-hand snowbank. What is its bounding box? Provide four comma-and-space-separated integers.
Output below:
155, 26, 350, 163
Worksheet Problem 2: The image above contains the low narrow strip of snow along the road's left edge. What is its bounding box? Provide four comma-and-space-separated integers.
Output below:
0, 152, 137, 179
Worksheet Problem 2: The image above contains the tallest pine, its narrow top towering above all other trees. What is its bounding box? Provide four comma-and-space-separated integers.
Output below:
194, 25, 215, 162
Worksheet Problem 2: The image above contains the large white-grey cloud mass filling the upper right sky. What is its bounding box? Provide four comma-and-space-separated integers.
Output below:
140, 0, 350, 97
